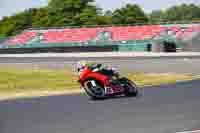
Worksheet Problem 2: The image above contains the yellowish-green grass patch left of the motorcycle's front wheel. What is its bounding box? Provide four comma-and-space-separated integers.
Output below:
0, 69, 78, 92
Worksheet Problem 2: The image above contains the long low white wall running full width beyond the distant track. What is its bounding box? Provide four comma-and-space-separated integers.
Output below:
0, 52, 200, 58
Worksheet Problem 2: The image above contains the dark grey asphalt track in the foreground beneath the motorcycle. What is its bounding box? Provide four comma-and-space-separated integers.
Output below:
0, 80, 200, 133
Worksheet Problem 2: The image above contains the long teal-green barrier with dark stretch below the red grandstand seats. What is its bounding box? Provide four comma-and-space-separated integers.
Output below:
0, 40, 150, 54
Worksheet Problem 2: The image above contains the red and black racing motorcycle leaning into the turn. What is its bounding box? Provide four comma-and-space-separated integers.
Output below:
78, 64, 138, 99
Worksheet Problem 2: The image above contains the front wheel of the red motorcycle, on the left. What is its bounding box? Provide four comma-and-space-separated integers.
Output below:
84, 79, 105, 100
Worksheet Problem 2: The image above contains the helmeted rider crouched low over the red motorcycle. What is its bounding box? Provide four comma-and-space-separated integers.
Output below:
77, 61, 118, 76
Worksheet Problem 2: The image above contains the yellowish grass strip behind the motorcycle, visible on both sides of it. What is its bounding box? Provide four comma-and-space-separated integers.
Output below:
0, 68, 192, 99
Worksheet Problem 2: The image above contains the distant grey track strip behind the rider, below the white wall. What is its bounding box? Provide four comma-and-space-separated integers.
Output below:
0, 57, 200, 75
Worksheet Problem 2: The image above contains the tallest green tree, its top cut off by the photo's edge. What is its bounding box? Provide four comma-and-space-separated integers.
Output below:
48, 0, 97, 26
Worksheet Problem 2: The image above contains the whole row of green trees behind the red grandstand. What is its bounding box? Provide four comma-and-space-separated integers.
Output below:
0, 0, 200, 36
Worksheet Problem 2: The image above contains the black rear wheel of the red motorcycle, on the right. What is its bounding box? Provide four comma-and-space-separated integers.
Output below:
120, 78, 138, 97
